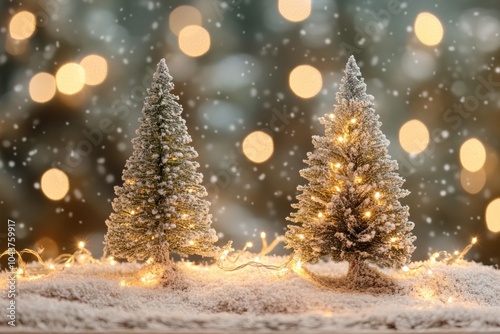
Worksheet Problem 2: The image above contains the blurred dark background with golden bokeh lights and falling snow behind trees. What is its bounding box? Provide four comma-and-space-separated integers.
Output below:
0, 0, 500, 265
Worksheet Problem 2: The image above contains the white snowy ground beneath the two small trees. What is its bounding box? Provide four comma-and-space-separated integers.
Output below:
0, 257, 500, 333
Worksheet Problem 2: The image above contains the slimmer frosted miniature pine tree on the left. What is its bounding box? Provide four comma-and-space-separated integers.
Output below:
105, 59, 217, 264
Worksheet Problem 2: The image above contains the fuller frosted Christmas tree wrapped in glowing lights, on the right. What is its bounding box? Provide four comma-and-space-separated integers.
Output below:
286, 56, 416, 277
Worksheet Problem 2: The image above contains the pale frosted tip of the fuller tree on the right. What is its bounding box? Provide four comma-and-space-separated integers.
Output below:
336, 56, 371, 104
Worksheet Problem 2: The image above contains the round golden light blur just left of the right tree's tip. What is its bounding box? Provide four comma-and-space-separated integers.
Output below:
288, 65, 323, 99
